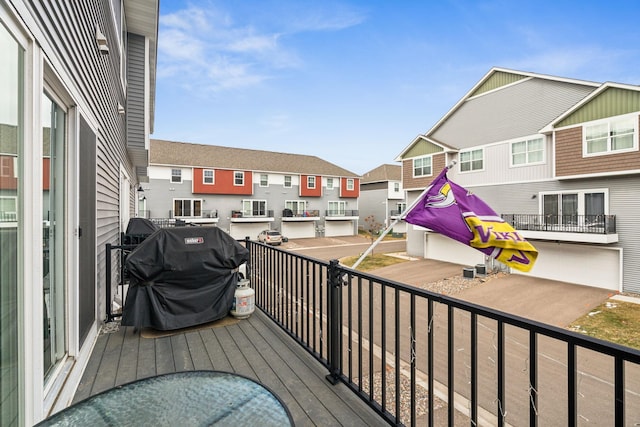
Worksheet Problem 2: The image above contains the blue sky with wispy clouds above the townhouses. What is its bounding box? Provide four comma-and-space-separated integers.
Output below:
152, 0, 640, 174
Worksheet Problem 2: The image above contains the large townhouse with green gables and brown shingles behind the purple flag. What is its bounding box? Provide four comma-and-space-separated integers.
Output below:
396, 68, 640, 292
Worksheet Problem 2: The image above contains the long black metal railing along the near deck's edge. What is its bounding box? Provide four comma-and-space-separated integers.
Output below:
245, 240, 640, 426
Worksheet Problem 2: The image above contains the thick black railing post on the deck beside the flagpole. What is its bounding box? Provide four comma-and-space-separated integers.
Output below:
327, 259, 342, 384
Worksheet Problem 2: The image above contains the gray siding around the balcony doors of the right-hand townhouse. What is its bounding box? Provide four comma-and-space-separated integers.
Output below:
465, 176, 640, 292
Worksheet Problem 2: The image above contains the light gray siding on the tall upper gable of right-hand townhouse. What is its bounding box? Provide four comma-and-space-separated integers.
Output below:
429, 78, 594, 149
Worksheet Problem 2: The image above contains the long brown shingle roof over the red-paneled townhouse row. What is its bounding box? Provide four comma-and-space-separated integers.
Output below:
149, 139, 359, 178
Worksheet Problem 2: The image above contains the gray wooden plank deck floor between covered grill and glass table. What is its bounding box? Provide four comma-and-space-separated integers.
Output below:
74, 311, 387, 426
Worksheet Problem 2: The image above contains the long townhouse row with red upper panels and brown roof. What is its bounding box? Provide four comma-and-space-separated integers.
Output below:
147, 139, 360, 239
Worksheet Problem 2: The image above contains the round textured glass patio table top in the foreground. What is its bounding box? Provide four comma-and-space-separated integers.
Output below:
38, 371, 293, 427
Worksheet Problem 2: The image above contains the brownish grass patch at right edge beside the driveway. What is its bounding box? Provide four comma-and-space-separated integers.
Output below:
569, 300, 640, 350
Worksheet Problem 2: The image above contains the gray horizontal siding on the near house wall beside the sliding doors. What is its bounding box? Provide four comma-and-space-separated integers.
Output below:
26, 1, 135, 313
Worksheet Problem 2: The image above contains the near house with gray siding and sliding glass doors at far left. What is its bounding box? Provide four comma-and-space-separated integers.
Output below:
0, 0, 158, 426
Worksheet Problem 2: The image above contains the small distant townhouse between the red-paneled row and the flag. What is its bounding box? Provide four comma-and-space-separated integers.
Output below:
358, 164, 407, 233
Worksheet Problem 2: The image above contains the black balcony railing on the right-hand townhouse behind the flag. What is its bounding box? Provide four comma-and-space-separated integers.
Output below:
502, 214, 616, 234
